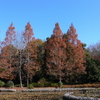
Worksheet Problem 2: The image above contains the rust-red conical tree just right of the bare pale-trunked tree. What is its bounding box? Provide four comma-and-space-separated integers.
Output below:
23, 23, 38, 87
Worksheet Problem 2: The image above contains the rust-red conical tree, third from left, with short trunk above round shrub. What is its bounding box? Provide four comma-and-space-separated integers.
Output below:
46, 23, 66, 82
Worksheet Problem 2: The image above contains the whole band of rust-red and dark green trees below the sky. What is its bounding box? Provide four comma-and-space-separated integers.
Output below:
0, 23, 100, 87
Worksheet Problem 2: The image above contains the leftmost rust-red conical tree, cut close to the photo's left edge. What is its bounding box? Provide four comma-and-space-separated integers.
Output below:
1, 23, 16, 80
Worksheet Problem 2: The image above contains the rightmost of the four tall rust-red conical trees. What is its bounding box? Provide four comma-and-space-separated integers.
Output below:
64, 24, 85, 82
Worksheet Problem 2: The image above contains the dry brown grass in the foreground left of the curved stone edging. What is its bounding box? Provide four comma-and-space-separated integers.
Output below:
0, 92, 65, 100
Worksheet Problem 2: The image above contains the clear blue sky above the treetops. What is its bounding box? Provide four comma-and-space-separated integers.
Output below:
0, 0, 100, 46
